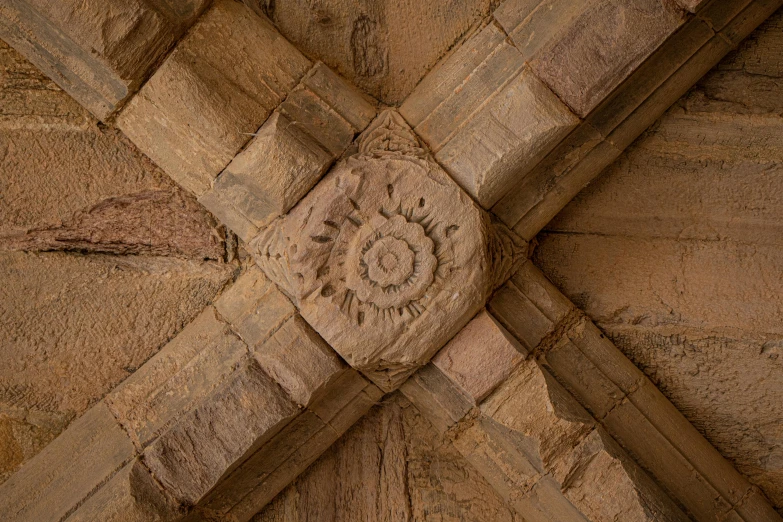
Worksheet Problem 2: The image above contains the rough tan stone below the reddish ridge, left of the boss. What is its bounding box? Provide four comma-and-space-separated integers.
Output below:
0, 252, 233, 425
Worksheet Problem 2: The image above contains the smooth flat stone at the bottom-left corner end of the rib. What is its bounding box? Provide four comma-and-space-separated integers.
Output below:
0, 402, 134, 522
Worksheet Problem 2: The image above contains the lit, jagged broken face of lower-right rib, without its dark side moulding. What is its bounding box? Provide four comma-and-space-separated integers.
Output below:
400, 311, 687, 521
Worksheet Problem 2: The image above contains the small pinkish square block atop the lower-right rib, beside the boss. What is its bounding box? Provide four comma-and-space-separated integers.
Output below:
432, 310, 524, 403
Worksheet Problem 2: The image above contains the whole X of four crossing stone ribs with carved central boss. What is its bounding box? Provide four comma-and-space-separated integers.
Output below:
0, 0, 783, 521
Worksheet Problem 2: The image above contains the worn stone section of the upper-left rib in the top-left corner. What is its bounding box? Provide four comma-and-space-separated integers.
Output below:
0, 0, 209, 119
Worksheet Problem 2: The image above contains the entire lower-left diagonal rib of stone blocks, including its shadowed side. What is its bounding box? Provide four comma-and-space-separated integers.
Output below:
0, 269, 382, 521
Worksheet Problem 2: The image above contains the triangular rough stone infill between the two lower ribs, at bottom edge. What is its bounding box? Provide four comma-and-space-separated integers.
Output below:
253, 394, 522, 522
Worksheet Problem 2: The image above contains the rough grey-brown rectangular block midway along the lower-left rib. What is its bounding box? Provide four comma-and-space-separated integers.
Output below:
143, 360, 299, 505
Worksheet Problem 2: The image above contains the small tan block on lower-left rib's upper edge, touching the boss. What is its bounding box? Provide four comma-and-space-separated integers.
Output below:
215, 267, 296, 348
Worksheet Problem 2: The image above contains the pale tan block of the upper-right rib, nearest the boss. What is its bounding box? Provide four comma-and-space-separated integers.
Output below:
435, 69, 579, 208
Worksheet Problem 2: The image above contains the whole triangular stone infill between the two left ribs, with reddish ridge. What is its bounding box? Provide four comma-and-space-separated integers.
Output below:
0, 42, 237, 482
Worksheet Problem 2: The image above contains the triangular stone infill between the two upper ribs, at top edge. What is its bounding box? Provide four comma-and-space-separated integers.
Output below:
251, 0, 495, 105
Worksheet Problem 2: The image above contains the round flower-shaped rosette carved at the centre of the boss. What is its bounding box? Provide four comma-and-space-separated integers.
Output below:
345, 215, 438, 309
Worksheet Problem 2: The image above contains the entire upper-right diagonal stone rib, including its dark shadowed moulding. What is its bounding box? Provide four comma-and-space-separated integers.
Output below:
400, 0, 783, 221
